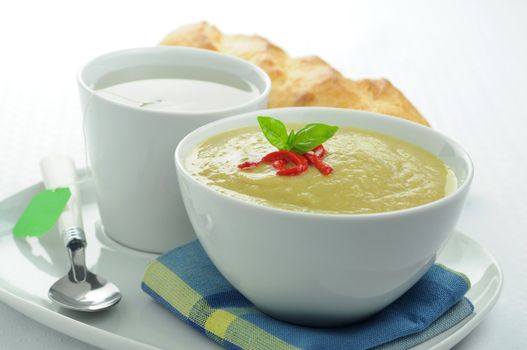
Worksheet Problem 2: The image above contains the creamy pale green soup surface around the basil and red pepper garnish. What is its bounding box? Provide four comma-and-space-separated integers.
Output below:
185, 125, 457, 214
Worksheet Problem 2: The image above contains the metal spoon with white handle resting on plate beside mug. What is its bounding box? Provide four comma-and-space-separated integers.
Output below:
40, 156, 121, 312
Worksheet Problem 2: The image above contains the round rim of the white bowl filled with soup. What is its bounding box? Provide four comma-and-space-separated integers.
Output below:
174, 107, 474, 220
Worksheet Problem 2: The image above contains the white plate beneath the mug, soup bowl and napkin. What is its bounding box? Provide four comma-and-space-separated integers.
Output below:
0, 176, 503, 350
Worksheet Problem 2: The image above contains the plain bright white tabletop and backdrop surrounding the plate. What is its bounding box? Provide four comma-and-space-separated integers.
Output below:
0, 0, 527, 350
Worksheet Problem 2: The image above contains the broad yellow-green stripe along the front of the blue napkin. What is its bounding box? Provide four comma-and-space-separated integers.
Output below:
143, 261, 299, 350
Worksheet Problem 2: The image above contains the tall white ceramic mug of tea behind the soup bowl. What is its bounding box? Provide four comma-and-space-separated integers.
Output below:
78, 46, 271, 253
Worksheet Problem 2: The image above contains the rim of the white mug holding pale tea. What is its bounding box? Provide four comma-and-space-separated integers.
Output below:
76, 45, 272, 117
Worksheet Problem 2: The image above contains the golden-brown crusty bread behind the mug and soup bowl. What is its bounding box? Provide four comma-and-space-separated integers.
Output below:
160, 22, 429, 126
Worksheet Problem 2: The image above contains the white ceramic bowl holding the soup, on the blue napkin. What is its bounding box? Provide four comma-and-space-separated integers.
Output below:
175, 107, 473, 326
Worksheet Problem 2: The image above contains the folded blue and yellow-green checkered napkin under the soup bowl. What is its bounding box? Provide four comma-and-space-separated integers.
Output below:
142, 241, 474, 350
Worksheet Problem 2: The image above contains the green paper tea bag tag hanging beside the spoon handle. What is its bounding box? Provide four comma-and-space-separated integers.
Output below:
13, 187, 71, 237
